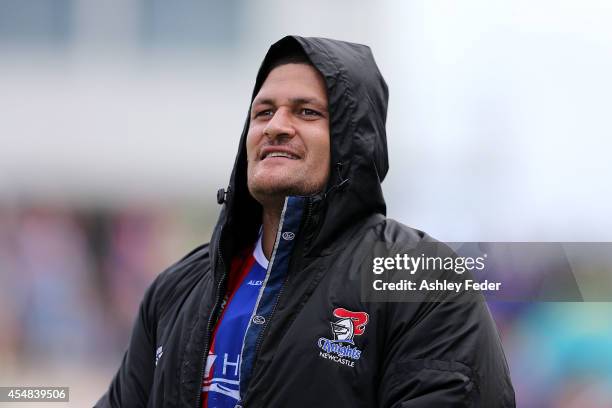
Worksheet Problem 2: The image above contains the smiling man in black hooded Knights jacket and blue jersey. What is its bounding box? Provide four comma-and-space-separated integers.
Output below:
97, 36, 514, 408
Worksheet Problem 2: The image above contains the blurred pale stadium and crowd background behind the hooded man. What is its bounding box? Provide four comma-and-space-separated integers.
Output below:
0, 0, 612, 408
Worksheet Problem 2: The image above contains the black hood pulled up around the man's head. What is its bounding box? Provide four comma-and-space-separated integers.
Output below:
212, 36, 389, 262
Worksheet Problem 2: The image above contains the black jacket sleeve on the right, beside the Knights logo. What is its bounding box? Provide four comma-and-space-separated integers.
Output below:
379, 300, 515, 408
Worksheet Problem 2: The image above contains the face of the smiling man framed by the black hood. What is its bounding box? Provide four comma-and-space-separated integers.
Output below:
246, 64, 330, 203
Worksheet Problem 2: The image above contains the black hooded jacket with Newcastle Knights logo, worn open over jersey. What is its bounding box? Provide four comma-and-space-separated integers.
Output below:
96, 36, 514, 408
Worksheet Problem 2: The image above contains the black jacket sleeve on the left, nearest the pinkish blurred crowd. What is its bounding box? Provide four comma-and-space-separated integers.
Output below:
95, 282, 156, 408
